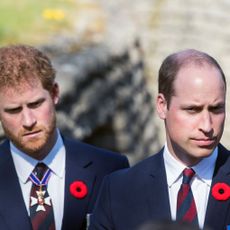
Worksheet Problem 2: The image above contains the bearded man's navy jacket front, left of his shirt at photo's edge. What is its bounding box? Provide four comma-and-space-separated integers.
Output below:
0, 141, 31, 230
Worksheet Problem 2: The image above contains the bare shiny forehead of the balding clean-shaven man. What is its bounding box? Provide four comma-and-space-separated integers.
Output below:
174, 65, 226, 101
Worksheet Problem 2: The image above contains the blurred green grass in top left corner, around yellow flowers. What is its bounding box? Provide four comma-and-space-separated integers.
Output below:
0, 0, 77, 46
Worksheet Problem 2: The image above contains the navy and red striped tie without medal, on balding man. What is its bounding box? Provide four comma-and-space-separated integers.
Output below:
176, 168, 198, 226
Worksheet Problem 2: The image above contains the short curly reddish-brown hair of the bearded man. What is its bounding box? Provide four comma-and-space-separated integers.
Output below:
0, 45, 55, 91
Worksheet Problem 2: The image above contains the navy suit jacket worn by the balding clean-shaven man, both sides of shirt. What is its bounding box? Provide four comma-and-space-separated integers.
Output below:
89, 145, 230, 230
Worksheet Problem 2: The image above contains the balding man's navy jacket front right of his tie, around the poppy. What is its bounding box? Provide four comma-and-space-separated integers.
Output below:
205, 145, 230, 230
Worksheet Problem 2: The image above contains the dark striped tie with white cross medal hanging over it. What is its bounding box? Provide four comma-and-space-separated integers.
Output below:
30, 163, 55, 230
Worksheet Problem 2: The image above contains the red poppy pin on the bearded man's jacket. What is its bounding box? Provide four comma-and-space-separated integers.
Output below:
69, 180, 88, 199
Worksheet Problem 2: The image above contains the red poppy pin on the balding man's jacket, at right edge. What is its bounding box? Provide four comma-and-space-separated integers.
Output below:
212, 183, 230, 200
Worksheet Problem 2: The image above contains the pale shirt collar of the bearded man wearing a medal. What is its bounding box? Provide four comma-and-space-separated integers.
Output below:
10, 130, 66, 183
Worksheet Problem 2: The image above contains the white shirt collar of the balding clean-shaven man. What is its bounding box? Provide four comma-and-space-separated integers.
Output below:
163, 143, 218, 187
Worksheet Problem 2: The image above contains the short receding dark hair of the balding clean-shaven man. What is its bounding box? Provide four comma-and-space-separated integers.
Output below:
158, 49, 226, 107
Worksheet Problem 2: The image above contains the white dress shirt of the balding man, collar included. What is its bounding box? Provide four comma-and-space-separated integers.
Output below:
163, 144, 218, 228
